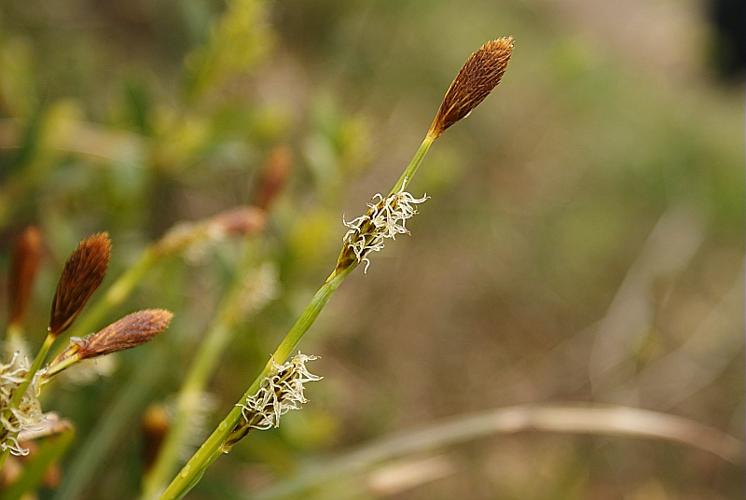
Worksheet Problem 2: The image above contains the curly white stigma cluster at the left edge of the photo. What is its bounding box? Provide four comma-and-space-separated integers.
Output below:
0, 353, 44, 455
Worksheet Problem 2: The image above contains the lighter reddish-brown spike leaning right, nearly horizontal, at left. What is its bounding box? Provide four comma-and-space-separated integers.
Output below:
72, 309, 173, 359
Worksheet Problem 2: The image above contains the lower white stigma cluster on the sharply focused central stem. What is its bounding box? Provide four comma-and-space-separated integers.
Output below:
237, 352, 322, 430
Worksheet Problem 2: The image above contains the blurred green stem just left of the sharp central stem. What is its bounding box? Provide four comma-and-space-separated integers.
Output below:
142, 251, 252, 499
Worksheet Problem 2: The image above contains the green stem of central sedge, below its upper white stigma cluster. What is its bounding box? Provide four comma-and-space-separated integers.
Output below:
160, 265, 357, 500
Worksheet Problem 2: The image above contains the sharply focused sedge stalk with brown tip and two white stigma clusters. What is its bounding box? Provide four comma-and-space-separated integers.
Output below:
161, 37, 513, 500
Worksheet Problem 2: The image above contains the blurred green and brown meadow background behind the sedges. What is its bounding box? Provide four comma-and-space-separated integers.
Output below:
0, 0, 745, 499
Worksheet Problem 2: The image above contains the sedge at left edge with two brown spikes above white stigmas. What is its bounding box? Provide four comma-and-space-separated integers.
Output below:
0, 233, 173, 470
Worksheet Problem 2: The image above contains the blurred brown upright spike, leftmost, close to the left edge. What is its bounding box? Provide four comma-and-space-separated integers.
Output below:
8, 226, 42, 324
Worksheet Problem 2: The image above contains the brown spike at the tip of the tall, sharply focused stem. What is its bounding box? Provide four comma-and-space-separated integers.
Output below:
428, 36, 513, 137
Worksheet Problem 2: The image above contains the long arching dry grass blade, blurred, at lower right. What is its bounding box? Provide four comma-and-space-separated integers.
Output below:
251, 404, 744, 500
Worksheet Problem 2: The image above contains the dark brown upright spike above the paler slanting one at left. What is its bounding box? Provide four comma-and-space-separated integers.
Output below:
49, 233, 111, 335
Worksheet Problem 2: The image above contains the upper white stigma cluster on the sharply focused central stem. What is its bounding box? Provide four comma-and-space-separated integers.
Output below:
342, 180, 430, 272
